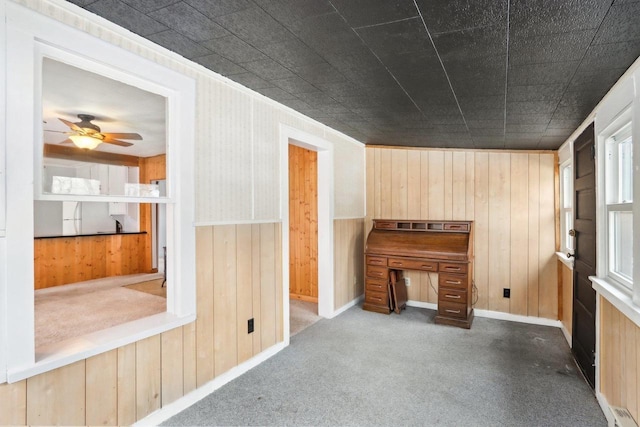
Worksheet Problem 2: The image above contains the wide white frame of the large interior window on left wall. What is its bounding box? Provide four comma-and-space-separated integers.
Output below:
0, 2, 196, 382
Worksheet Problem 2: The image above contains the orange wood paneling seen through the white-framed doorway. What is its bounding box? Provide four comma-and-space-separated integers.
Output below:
289, 144, 318, 303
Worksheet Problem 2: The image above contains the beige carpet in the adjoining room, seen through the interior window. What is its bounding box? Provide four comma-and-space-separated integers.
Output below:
35, 275, 167, 352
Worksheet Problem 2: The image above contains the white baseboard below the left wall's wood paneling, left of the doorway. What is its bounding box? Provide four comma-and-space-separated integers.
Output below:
133, 342, 287, 426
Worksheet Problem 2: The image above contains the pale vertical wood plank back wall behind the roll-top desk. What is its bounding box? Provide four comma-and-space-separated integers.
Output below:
366, 147, 558, 319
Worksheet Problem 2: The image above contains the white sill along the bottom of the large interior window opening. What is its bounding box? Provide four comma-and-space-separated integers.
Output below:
7, 313, 196, 383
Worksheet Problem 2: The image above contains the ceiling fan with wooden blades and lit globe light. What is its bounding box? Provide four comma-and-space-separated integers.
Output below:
49, 114, 142, 150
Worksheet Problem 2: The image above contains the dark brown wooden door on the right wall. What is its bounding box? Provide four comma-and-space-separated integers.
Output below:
572, 123, 596, 387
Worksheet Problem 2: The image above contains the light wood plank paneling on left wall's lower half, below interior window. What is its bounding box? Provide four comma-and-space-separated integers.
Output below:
0, 223, 283, 425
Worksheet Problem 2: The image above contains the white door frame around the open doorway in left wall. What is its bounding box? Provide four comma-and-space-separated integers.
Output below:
279, 124, 336, 344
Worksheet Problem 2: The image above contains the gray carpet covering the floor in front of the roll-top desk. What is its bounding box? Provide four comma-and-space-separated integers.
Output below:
164, 307, 606, 426
